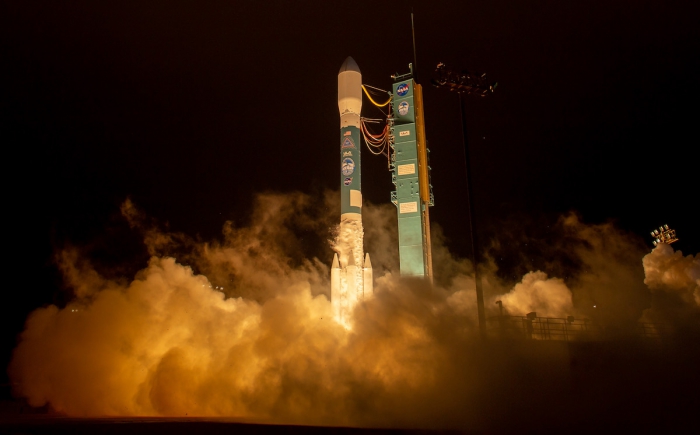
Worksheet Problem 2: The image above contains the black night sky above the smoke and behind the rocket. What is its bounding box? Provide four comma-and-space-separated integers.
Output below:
0, 0, 700, 402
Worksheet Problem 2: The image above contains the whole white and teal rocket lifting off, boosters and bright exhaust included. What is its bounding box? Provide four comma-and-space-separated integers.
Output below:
331, 57, 373, 327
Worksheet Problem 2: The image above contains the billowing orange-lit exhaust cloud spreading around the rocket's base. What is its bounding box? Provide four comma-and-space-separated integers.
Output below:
9, 193, 700, 427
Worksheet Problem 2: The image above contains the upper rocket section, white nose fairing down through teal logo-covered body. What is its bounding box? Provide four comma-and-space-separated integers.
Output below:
338, 57, 362, 222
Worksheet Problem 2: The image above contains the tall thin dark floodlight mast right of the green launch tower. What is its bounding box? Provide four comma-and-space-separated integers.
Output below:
432, 62, 497, 337
